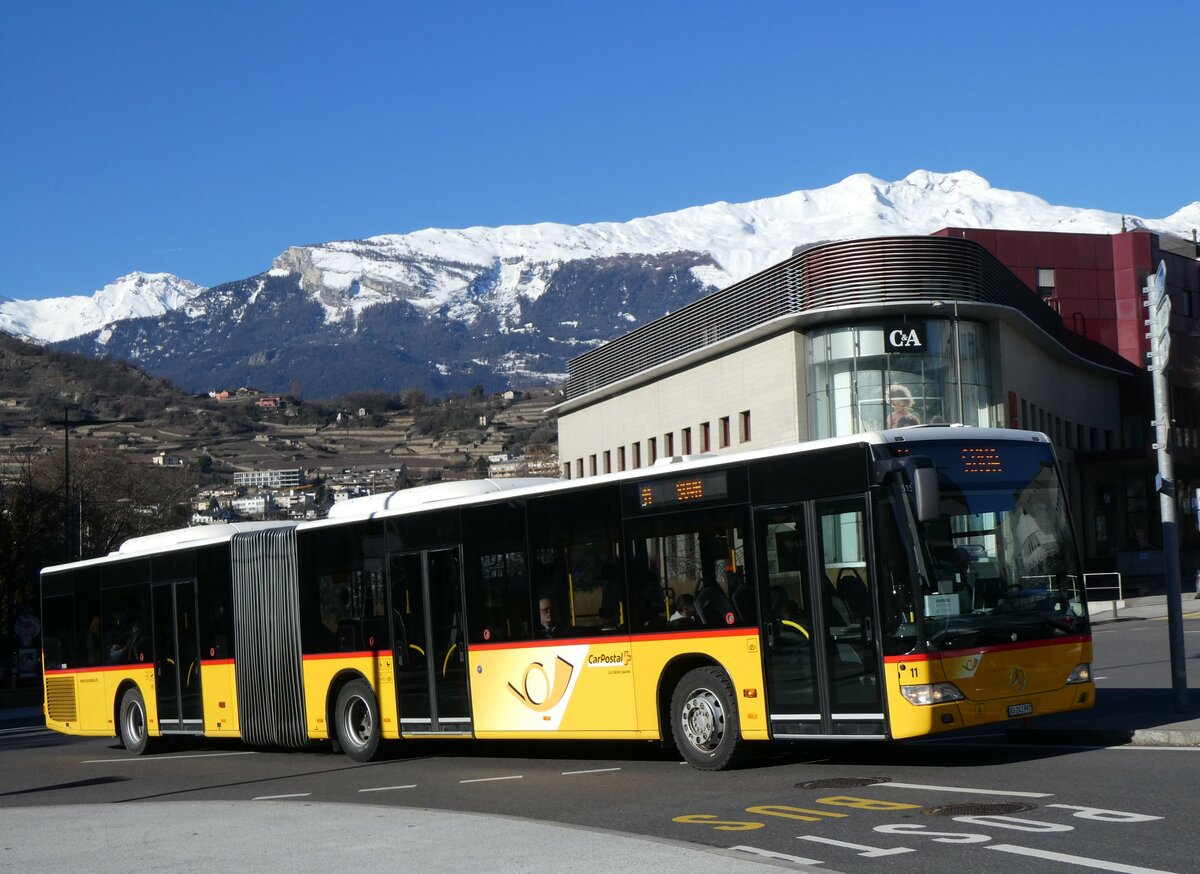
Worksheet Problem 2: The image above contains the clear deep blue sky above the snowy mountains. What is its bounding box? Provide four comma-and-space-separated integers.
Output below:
0, 0, 1200, 298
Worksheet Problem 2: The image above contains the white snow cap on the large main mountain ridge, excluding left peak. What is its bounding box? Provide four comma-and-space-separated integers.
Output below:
275, 165, 1161, 325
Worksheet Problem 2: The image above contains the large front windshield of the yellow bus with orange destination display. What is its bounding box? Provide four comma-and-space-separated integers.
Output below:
893, 441, 1087, 648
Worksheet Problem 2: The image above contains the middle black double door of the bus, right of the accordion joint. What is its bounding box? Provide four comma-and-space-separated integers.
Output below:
390, 547, 472, 735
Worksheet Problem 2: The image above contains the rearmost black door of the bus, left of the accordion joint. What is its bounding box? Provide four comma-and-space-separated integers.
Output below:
150, 580, 204, 734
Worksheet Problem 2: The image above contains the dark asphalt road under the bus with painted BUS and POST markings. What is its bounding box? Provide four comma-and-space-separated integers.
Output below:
0, 621, 1200, 874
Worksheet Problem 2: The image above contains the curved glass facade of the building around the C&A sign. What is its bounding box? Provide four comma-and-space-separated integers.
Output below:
808, 319, 998, 439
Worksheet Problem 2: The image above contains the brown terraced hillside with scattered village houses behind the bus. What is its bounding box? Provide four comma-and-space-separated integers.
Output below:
0, 337, 560, 525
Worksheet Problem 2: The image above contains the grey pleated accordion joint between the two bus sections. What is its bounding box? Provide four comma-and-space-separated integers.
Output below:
229, 527, 307, 747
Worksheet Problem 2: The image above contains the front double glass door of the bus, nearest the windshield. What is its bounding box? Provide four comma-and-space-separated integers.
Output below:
755, 498, 886, 737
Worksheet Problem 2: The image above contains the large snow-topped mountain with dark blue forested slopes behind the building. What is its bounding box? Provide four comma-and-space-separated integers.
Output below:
32, 170, 1200, 396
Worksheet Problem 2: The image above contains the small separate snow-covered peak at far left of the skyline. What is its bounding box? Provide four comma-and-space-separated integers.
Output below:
0, 273, 204, 343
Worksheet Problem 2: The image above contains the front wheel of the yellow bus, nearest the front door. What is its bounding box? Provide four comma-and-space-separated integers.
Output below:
671, 668, 742, 771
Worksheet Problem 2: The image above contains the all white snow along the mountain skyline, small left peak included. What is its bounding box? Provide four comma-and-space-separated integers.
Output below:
9, 169, 1200, 345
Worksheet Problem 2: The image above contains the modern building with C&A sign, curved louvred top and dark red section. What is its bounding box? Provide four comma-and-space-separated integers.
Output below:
554, 228, 1200, 585
